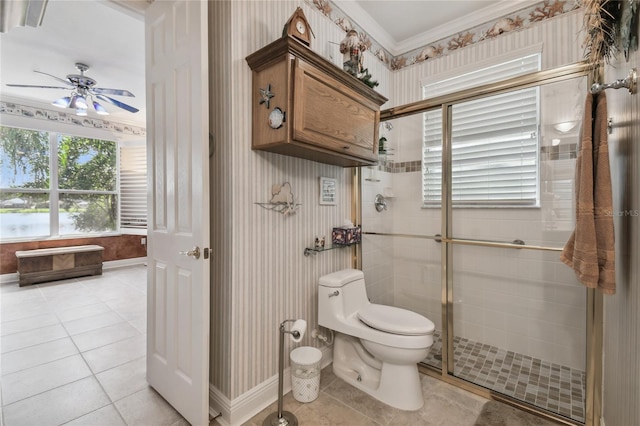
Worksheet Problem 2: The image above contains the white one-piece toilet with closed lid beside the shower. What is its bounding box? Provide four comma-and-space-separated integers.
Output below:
318, 269, 435, 410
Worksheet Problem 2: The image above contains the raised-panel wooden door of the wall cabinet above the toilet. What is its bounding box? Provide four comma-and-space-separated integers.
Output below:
292, 59, 380, 161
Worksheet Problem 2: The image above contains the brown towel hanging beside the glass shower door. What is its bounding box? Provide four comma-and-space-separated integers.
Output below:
560, 92, 616, 294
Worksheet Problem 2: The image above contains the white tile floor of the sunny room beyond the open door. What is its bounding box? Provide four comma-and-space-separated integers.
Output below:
0, 265, 188, 426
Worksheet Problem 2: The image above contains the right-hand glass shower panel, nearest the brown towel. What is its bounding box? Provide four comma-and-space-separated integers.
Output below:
445, 78, 587, 422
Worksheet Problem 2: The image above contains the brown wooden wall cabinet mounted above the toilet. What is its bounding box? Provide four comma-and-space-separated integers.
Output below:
246, 37, 387, 167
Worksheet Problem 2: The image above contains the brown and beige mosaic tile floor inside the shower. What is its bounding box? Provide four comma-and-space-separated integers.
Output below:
425, 331, 586, 423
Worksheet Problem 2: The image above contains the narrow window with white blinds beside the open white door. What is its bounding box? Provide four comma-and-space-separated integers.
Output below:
120, 145, 147, 230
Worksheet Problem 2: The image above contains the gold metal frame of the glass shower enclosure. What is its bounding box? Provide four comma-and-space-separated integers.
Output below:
352, 62, 603, 426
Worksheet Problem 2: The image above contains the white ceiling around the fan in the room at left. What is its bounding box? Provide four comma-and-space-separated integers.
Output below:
0, 0, 146, 126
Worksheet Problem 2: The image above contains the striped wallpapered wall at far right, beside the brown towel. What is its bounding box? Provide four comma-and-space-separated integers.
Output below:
603, 47, 640, 426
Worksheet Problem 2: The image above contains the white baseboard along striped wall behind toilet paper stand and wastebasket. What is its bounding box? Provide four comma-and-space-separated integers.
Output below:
209, 346, 333, 426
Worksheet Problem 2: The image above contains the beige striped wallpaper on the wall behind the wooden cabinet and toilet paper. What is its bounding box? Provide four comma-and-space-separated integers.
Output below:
209, 1, 389, 400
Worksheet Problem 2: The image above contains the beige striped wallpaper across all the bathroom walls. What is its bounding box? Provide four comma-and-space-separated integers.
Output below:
209, 4, 640, 425
